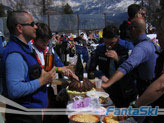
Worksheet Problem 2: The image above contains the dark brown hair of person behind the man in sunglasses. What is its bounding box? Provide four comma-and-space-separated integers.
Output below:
36, 23, 52, 41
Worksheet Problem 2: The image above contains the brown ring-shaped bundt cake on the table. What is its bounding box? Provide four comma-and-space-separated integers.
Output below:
68, 79, 95, 92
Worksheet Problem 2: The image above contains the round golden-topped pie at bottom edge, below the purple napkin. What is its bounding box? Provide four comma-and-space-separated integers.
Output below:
70, 113, 100, 123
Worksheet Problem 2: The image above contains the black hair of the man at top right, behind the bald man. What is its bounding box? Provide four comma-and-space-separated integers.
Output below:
128, 4, 142, 20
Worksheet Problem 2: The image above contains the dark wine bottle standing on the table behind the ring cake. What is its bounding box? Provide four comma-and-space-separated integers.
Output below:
75, 53, 84, 81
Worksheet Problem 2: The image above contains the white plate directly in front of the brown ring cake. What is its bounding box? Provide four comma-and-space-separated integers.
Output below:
86, 91, 109, 98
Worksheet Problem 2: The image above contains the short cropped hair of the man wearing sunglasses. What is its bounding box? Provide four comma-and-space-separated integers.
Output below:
6, 11, 29, 34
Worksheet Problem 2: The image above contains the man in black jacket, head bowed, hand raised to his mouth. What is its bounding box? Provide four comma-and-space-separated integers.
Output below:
89, 25, 136, 107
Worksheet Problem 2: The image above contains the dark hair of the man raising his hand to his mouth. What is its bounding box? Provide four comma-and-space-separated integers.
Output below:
103, 25, 119, 39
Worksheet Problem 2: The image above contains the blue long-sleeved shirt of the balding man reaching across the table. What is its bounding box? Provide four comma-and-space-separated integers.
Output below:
118, 34, 160, 80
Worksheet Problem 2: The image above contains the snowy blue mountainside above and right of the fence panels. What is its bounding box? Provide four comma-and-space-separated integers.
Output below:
54, 0, 141, 23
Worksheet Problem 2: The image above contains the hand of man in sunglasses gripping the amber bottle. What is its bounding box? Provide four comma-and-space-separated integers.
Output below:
38, 67, 56, 85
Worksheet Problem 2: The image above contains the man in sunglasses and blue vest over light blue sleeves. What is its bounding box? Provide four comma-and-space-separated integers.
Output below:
1, 11, 56, 123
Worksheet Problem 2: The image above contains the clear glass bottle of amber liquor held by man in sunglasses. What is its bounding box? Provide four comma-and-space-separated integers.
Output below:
45, 41, 54, 72
